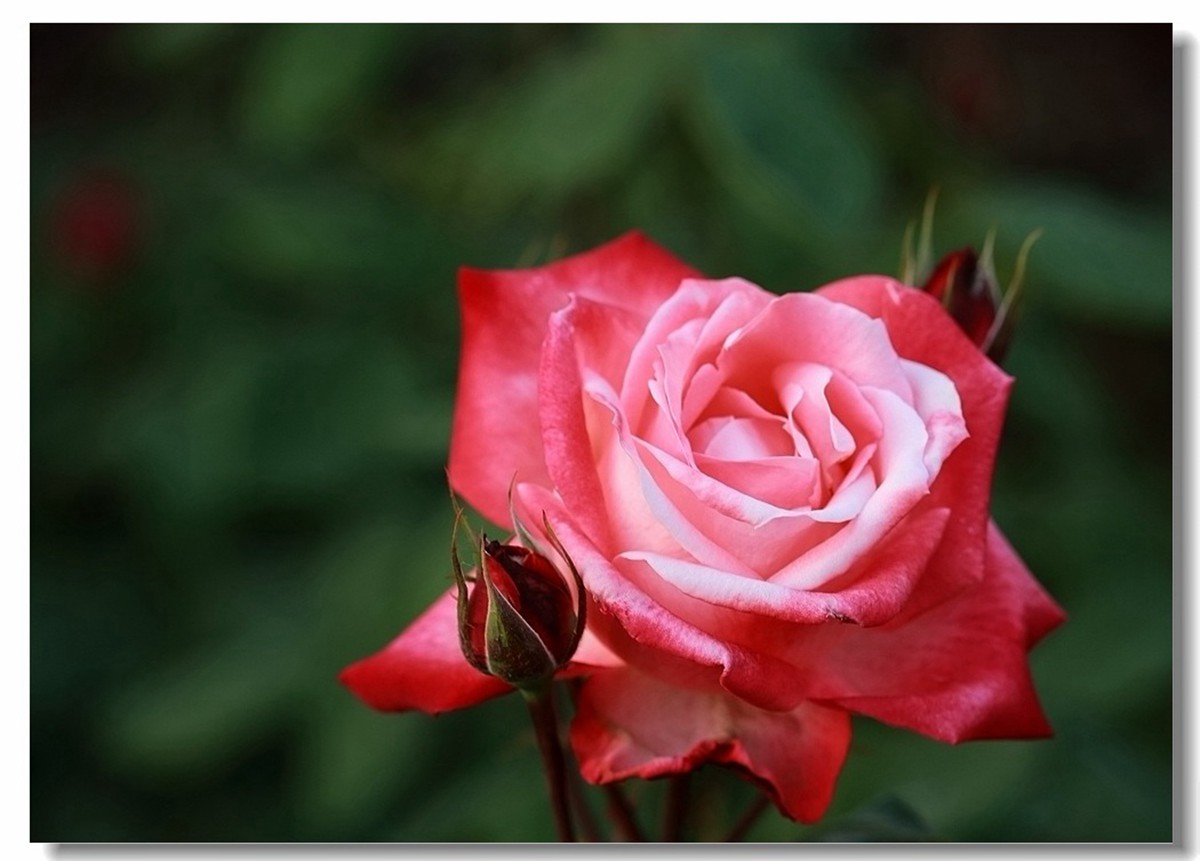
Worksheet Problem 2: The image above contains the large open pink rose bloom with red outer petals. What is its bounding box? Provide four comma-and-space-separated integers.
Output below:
342, 234, 1063, 821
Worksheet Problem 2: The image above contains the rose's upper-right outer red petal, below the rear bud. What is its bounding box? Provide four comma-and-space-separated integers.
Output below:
817, 276, 1013, 612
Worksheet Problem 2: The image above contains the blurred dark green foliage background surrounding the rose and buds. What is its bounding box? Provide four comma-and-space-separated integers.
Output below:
30, 25, 1172, 842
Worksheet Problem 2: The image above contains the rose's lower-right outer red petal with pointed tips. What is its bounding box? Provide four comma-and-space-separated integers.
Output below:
823, 524, 1064, 742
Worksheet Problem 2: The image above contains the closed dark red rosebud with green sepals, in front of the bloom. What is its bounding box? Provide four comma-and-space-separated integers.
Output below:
451, 523, 586, 691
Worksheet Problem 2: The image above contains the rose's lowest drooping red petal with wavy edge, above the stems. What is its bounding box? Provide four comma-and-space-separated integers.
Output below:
571, 668, 850, 821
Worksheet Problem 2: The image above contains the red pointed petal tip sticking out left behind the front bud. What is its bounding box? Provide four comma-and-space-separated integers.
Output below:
340, 589, 512, 715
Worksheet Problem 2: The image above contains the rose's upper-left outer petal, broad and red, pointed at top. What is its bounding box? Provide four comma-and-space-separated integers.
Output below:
450, 233, 696, 525
